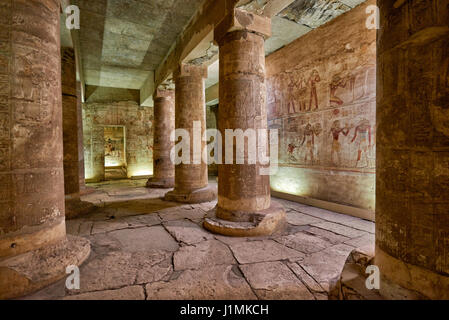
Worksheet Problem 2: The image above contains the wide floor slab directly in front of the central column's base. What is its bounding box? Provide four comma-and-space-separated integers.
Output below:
230, 240, 304, 264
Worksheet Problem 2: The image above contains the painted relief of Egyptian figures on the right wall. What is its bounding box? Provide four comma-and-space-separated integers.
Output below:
267, 52, 376, 170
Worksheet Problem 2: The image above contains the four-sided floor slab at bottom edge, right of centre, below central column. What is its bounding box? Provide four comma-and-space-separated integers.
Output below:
240, 261, 314, 300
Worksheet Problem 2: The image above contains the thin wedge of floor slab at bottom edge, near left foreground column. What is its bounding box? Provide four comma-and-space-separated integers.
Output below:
63, 286, 145, 300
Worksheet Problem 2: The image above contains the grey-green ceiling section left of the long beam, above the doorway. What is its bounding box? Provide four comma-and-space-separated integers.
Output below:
73, 0, 203, 89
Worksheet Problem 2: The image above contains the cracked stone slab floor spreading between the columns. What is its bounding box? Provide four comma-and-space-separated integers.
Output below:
24, 180, 374, 300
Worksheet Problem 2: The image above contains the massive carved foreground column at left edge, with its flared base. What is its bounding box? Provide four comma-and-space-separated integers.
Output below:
0, 0, 90, 299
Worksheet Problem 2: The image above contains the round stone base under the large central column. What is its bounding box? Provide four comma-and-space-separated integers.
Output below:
203, 201, 286, 237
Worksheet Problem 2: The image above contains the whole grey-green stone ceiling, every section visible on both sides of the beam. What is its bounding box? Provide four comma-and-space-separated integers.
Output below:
72, 0, 365, 94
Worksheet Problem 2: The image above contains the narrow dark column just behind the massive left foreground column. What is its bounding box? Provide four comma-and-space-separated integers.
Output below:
61, 47, 95, 218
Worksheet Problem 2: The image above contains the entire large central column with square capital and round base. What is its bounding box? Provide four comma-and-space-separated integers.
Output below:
204, 9, 285, 236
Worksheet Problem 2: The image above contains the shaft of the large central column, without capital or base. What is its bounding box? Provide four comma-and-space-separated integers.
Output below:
217, 31, 271, 220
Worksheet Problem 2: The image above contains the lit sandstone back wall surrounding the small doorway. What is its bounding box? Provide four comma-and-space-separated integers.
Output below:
83, 101, 153, 181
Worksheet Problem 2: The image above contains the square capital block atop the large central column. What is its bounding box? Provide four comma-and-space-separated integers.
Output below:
214, 8, 271, 43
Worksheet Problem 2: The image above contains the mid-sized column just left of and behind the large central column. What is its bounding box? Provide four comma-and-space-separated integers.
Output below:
165, 64, 216, 203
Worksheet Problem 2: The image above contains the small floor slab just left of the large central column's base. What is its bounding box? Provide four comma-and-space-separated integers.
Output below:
164, 220, 214, 244
